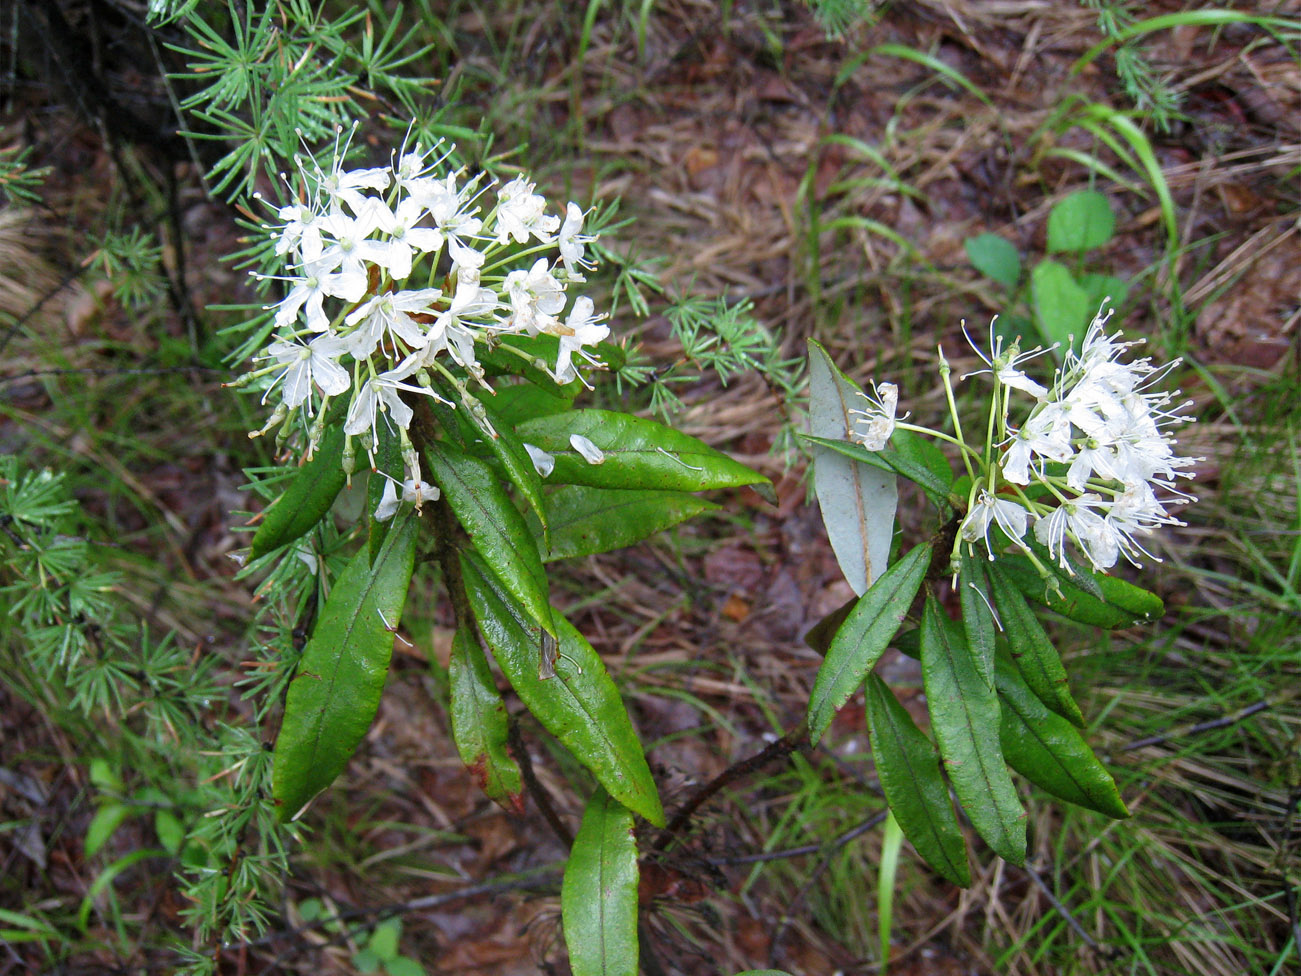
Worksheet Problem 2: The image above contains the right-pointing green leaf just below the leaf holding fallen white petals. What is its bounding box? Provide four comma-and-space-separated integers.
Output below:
530, 484, 718, 562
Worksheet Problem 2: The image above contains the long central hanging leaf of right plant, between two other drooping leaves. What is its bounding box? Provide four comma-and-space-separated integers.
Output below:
921, 596, 1025, 864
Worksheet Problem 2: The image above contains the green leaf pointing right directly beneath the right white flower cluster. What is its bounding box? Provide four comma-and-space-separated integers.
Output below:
998, 556, 1164, 630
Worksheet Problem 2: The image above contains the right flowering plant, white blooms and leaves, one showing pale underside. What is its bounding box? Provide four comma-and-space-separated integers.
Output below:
808, 314, 1196, 885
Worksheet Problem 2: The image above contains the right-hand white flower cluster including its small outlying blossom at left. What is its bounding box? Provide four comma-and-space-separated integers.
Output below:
855, 312, 1197, 570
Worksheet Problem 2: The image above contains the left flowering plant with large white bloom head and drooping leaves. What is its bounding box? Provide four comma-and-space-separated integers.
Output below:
231, 126, 766, 972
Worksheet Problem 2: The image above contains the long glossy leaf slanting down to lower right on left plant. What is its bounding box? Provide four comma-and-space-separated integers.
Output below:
461, 552, 665, 826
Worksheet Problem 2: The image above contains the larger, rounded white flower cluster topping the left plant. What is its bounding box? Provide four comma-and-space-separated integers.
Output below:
244, 125, 609, 498
